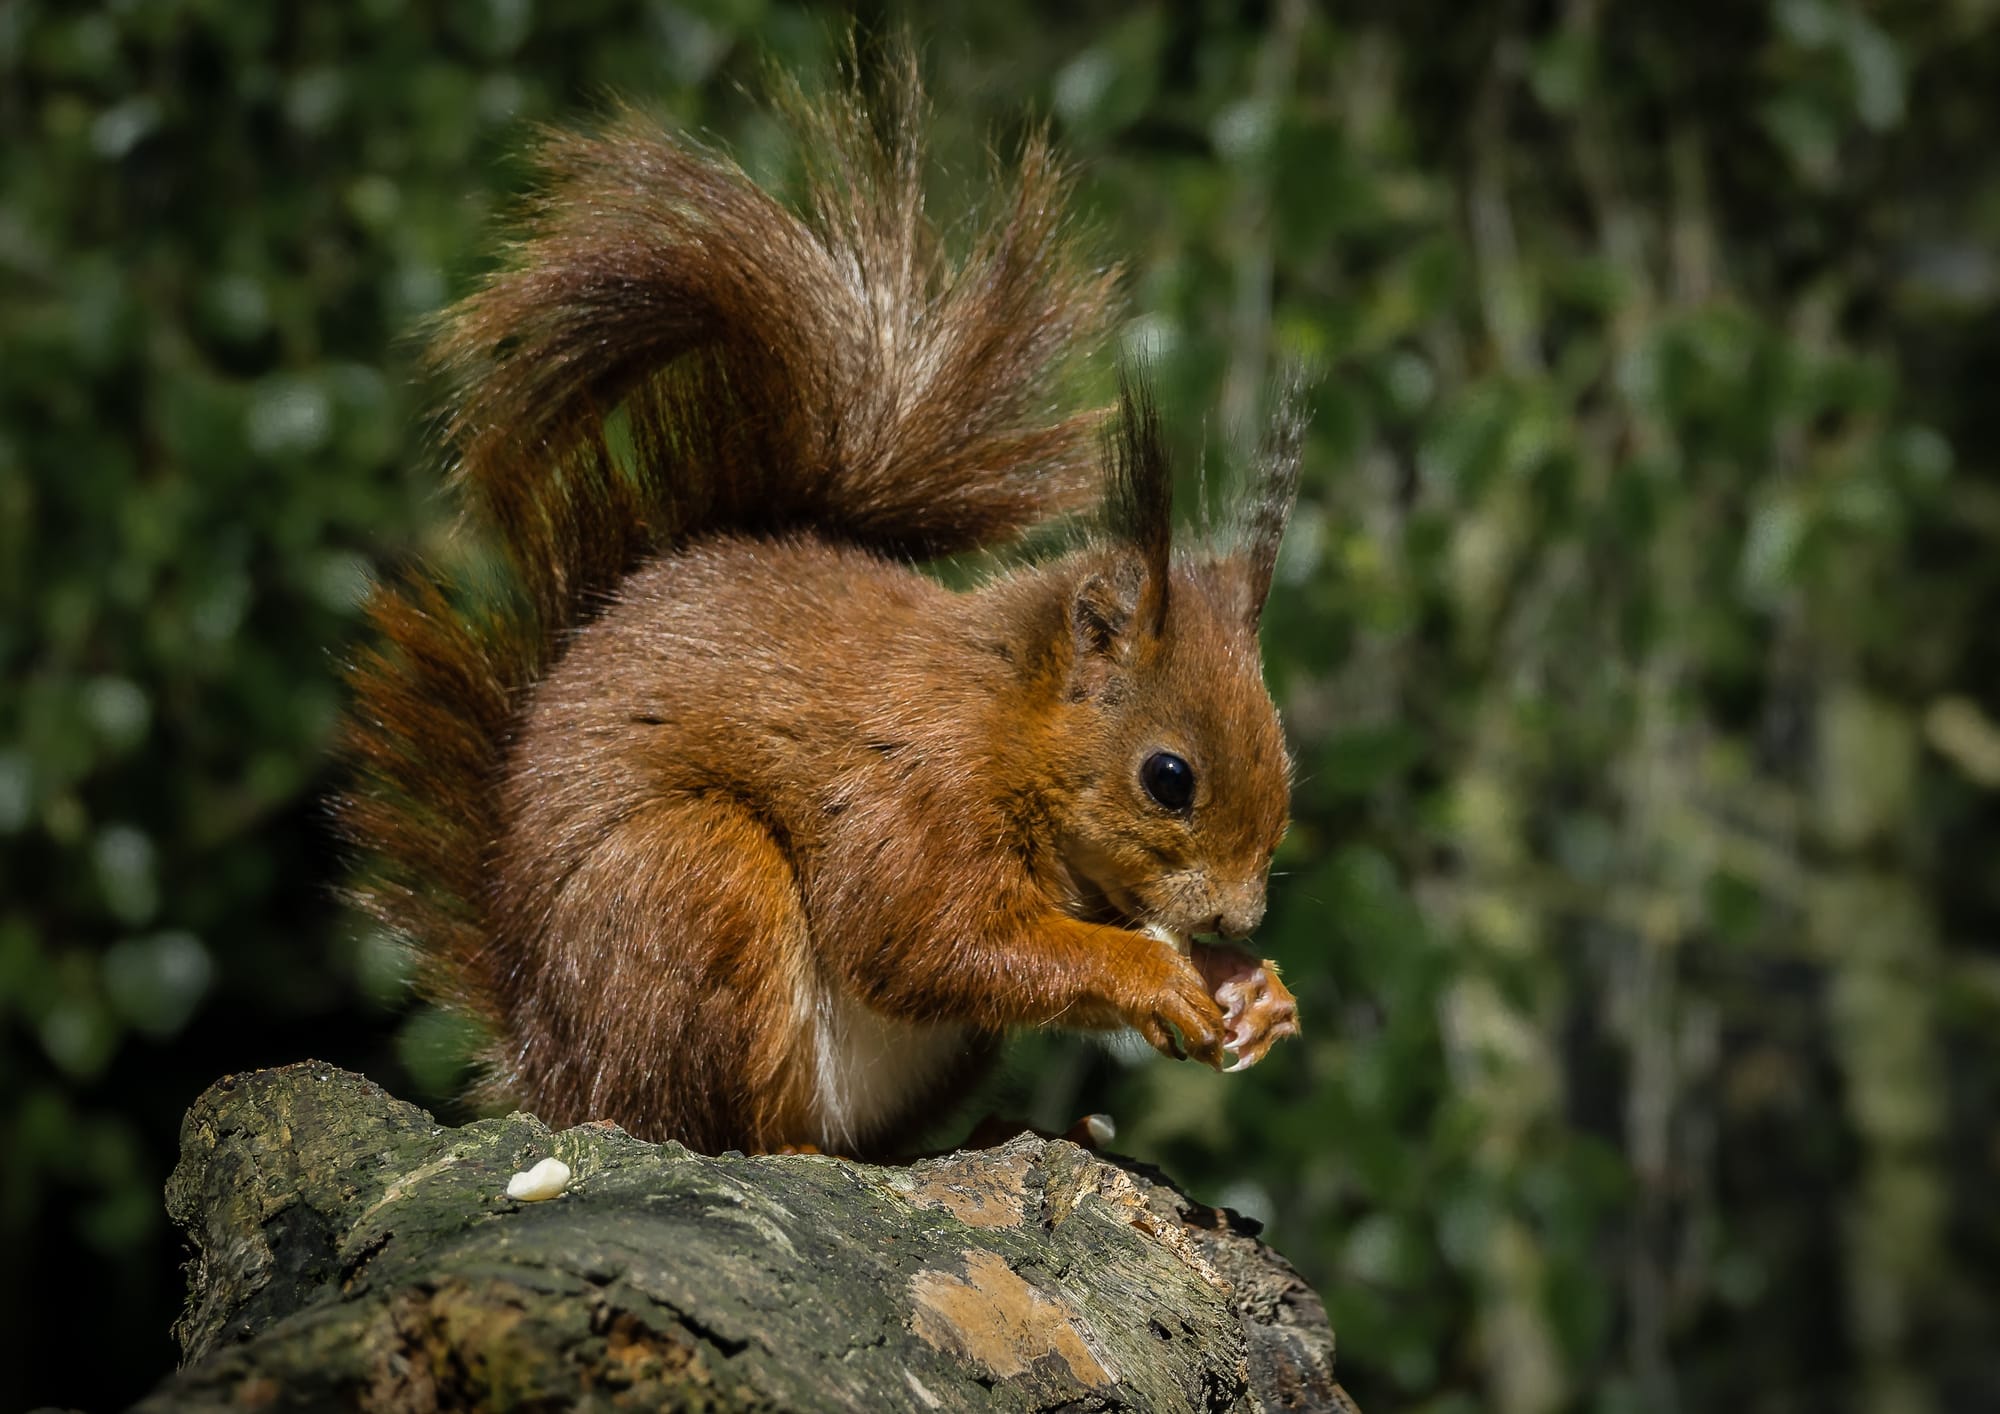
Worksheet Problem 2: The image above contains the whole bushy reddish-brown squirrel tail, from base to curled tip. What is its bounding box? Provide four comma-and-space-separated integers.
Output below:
338, 54, 1114, 1022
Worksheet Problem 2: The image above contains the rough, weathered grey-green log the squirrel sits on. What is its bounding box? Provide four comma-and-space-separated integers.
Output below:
140, 1062, 1352, 1414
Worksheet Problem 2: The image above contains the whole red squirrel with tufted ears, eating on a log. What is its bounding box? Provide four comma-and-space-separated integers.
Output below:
338, 60, 1304, 1156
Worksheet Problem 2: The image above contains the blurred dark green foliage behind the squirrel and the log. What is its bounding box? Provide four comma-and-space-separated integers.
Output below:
0, 0, 2000, 1414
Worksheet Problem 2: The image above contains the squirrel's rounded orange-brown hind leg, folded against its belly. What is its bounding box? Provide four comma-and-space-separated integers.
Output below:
504, 796, 822, 1152
